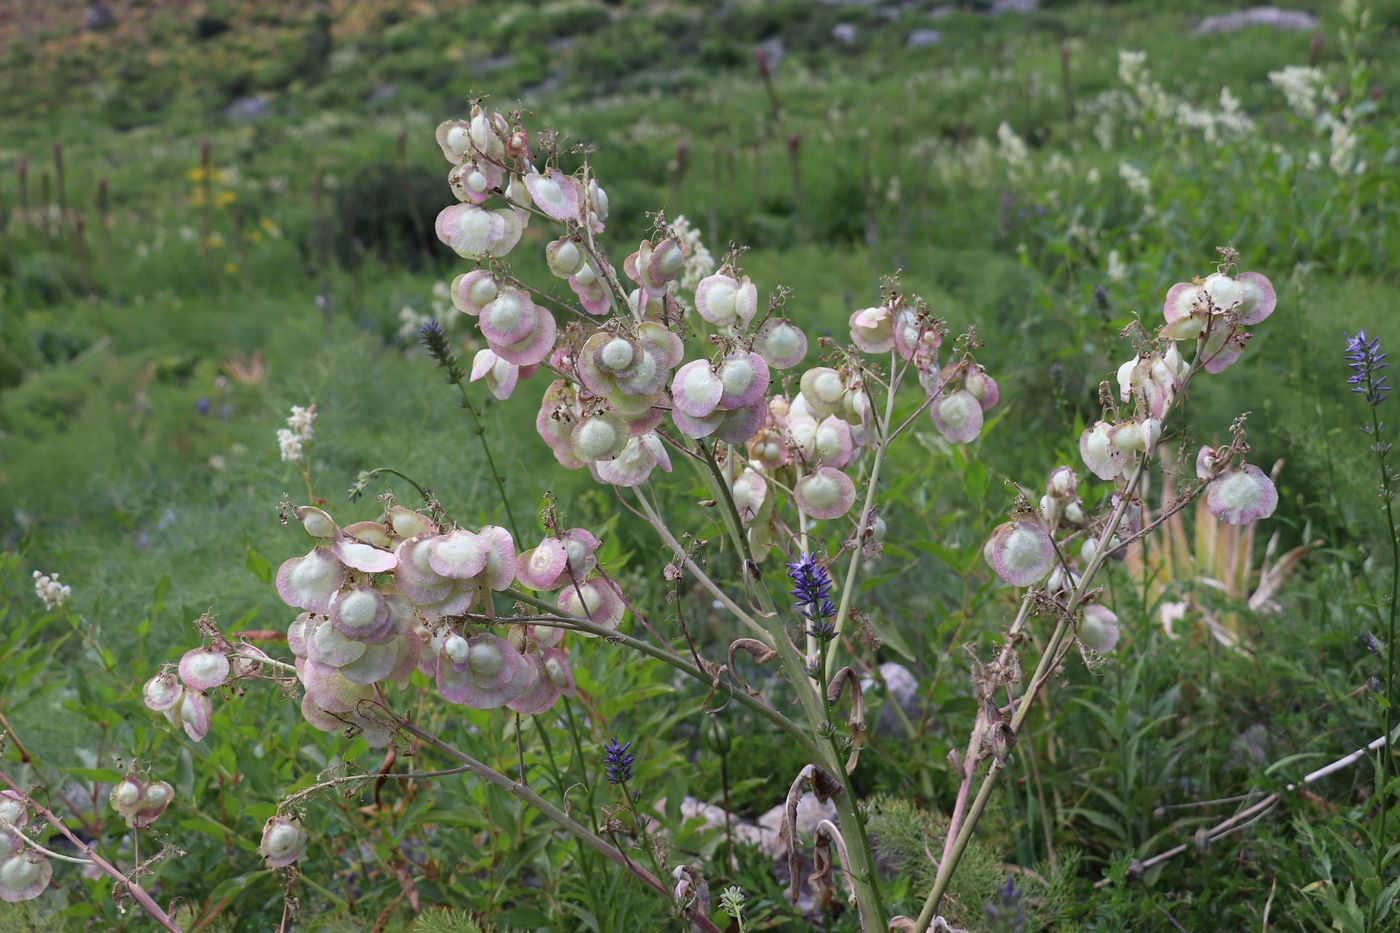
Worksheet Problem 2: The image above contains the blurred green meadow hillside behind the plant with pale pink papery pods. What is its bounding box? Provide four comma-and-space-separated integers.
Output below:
0, 0, 1400, 930
